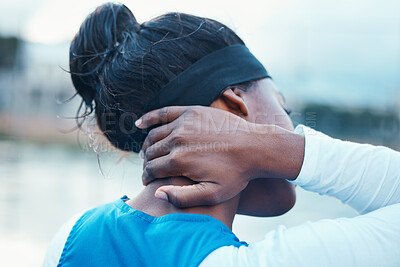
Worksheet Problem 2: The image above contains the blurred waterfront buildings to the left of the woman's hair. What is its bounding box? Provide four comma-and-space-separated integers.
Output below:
0, 38, 76, 141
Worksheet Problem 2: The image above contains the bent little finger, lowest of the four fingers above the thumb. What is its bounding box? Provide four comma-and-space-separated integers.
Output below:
142, 154, 182, 185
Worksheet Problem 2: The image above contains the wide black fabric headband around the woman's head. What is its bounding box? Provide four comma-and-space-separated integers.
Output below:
144, 44, 270, 112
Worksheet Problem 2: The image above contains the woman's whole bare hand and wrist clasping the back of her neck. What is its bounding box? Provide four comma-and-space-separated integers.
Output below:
137, 106, 304, 207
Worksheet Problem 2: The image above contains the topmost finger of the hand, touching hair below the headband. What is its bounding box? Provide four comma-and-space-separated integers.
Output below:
135, 106, 190, 129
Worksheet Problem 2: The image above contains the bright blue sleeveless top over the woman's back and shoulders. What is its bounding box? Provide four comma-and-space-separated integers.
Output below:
58, 196, 247, 267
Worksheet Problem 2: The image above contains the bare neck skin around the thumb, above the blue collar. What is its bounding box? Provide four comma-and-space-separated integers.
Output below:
127, 177, 239, 230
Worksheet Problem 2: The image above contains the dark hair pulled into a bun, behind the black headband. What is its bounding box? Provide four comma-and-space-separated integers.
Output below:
70, 3, 248, 152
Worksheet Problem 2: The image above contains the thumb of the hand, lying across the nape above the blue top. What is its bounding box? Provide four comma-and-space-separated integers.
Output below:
154, 182, 223, 208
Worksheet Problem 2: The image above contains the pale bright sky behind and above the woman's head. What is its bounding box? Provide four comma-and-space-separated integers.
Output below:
0, 0, 400, 109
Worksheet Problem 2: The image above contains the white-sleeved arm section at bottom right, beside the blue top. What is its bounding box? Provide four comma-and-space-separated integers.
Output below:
200, 204, 400, 267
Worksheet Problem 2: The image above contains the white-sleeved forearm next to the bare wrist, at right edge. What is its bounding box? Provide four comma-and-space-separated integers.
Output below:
294, 126, 400, 213
